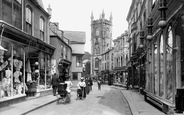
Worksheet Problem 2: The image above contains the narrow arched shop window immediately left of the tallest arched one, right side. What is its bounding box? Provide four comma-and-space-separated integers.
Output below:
159, 35, 164, 97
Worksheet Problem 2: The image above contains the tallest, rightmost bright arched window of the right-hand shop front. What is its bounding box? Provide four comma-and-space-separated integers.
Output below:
166, 27, 173, 101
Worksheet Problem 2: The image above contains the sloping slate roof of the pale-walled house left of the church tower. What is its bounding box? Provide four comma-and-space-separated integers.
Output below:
64, 31, 86, 43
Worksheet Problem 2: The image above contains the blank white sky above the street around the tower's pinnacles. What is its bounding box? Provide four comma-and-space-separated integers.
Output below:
42, 0, 132, 53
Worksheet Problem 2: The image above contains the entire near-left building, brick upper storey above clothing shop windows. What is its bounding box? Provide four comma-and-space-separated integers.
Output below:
0, 0, 55, 106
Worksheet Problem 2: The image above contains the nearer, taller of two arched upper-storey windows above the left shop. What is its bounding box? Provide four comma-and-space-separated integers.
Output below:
26, 6, 32, 35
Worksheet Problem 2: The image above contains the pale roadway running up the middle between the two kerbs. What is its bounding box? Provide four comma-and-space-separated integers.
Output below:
27, 83, 132, 115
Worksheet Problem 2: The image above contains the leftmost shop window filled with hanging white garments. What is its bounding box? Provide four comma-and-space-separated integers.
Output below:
0, 42, 24, 98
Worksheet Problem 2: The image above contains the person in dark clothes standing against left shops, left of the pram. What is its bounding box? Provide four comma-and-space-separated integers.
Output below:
51, 73, 58, 96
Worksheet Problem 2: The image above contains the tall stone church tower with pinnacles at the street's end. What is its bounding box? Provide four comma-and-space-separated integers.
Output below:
91, 11, 112, 76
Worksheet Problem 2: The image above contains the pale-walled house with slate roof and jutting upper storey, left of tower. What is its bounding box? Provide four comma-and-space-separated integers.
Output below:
64, 31, 86, 80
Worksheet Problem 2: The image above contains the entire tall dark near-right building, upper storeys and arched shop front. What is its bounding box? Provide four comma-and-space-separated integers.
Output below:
127, 0, 184, 113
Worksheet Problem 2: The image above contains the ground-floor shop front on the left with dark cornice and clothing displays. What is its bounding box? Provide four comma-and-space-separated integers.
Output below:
0, 22, 55, 107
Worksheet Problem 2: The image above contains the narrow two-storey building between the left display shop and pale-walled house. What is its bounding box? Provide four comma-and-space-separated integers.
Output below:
50, 22, 72, 80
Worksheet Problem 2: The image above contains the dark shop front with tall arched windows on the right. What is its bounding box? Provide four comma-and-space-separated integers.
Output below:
145, 0, 184, 113
